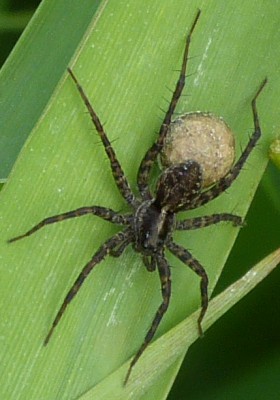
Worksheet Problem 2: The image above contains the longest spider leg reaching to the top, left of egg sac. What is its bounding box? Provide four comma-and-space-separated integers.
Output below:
137, 10, 201, 200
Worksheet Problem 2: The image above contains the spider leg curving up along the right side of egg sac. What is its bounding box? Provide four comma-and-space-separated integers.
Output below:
188, 78, 267, 209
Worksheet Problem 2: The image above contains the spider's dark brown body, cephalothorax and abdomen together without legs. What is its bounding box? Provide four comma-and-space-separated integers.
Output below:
133, 161, 202, 256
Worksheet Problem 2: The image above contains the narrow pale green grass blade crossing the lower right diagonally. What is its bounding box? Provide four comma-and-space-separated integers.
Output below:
79, 249, 280, 400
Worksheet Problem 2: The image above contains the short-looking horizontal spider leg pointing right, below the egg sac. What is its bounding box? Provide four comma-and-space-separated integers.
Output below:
175, 213, 243, 231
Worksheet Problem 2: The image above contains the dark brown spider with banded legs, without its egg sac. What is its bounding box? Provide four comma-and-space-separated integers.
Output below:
9, 10, 267, 384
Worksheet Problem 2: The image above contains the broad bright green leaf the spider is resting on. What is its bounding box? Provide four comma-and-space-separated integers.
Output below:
0, 0, 280, 399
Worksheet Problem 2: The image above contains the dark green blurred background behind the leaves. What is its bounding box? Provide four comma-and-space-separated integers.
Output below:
0, 0, 280, 400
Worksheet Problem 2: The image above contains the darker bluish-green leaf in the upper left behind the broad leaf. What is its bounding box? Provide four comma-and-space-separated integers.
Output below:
0, 0, 100, 181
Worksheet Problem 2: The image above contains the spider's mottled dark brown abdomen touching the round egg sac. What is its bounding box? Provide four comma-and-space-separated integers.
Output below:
155, 160, 203, 212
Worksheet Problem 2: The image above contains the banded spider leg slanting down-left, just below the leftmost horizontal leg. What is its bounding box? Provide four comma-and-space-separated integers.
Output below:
44, 229, 131, 346
